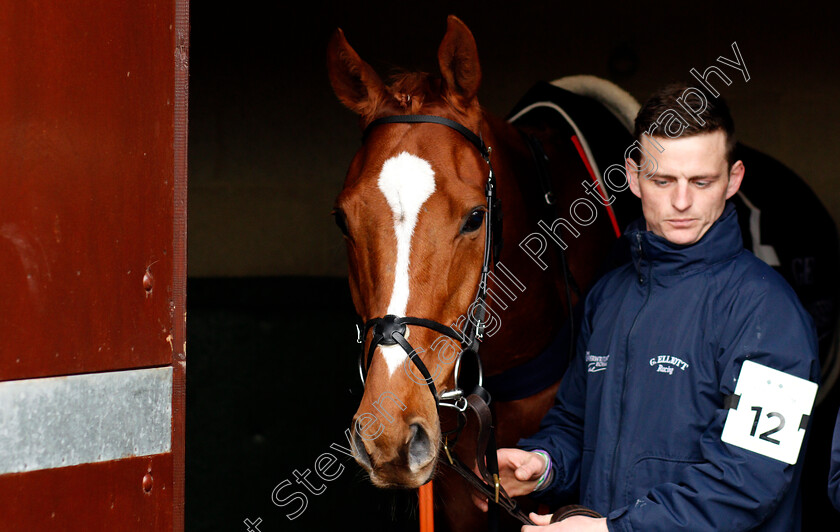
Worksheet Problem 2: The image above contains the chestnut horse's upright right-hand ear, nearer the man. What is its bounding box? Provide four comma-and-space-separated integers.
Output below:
438, 15, 481, 107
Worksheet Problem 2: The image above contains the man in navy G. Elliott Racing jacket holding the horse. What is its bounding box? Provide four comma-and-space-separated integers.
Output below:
482, 86, 819, 532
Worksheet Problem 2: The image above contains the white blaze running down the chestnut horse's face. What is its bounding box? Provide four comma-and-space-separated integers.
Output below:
378, 152, 435, 375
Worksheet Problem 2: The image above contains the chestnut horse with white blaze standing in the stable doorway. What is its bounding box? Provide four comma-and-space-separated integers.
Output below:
327, 16, 632, 531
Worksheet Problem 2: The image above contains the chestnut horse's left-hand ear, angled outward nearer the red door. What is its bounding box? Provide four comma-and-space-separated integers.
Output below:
327, 28, 386, 117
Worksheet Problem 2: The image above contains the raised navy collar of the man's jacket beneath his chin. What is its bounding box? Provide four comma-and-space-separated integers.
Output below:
625, 202, 744, 277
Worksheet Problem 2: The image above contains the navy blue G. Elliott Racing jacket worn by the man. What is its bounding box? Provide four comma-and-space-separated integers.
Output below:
519, 204, 819, 532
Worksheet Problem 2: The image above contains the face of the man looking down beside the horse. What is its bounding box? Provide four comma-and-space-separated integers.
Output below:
626, 131, 744, 245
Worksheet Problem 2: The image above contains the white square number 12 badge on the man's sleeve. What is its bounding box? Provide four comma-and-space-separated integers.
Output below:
721, 360, 817, 464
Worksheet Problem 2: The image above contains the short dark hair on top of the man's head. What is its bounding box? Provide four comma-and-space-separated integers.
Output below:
633, 82, 735, 166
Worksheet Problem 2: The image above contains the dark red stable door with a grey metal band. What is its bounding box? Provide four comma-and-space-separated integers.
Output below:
0, 0, 189, 531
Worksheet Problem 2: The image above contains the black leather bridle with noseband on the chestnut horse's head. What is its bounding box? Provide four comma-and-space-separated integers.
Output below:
357, 115, 534, 530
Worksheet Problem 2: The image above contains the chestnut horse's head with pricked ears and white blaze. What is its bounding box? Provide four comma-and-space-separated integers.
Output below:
328, 16, 498, 487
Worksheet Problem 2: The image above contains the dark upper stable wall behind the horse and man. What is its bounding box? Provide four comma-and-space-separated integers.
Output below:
189, 1, 840, 277
